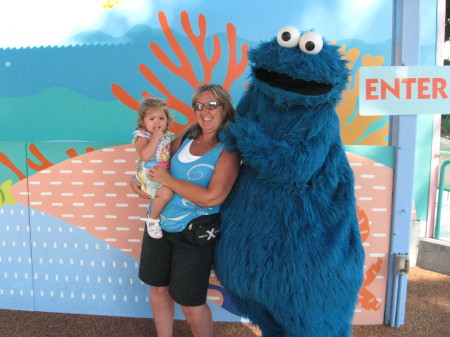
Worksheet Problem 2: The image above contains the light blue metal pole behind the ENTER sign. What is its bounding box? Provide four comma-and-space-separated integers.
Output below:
385, 0, 420, 327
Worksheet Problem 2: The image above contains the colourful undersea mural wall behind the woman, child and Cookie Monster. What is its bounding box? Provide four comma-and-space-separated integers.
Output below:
0, 0, 436, 324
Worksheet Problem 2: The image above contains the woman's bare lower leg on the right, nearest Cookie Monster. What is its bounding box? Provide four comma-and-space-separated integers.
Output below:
181, 304, 214, 337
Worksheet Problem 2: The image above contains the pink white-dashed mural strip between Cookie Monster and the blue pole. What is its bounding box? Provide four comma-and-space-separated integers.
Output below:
348, 154, 393, 324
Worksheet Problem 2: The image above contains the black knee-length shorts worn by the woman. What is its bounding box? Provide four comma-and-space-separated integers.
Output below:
139, 226, 215, 306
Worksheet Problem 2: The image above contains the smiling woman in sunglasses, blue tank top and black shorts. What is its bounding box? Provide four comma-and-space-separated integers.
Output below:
131, 84, 240, 337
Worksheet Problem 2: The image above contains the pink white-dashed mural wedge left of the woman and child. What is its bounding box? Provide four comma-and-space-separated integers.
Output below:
12, 145, 144, 259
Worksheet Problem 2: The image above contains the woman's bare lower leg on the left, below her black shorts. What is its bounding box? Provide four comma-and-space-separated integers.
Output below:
150, 287, 174, 337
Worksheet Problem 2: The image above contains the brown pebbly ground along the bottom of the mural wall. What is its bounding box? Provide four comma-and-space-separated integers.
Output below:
0, 267, 450, 337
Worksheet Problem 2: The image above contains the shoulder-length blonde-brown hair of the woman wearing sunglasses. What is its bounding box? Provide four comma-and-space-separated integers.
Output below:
188, 84, 236, 138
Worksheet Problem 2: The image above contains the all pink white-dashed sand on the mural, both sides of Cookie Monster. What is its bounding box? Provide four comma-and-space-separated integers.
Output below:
11, 144, 392, 324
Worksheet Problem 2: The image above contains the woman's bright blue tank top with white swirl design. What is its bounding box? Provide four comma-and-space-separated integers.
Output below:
160, 139, 224, 232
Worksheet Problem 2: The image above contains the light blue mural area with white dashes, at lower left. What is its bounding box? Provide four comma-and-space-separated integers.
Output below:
0, 204, 240, 321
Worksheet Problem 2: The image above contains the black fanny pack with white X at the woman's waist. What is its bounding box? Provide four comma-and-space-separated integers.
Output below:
182, 213, 220, 246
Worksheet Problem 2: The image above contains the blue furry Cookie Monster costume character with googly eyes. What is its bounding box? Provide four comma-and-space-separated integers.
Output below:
215, 26, 364, 337
